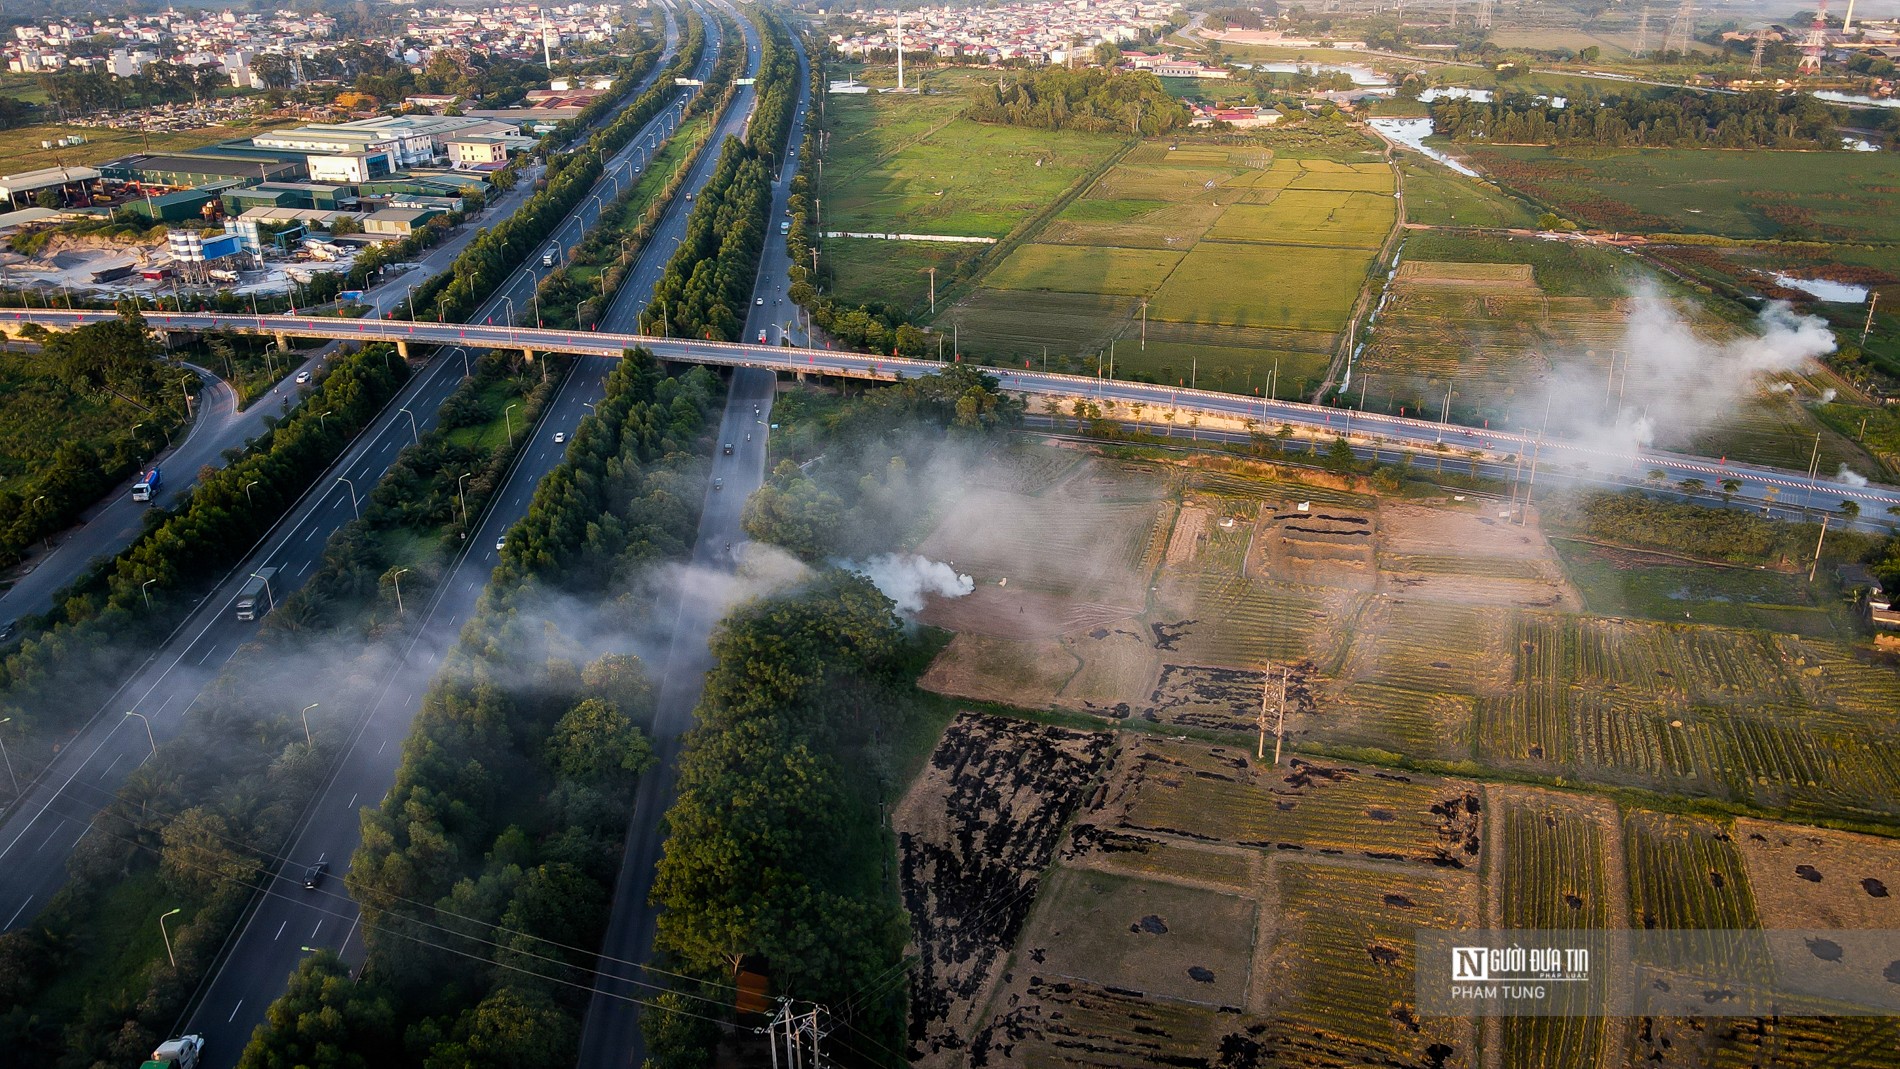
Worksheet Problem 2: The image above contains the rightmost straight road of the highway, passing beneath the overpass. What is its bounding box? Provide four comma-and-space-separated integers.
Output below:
580, 12, 811, 1069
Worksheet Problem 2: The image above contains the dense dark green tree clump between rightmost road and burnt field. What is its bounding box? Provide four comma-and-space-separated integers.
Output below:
642, 570, 920, 1069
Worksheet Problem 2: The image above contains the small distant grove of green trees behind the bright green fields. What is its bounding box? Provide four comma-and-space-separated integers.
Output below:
963, 66, 1189, 137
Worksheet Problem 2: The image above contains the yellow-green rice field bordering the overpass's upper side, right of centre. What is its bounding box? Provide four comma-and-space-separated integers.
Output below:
937, 139, 1395, 397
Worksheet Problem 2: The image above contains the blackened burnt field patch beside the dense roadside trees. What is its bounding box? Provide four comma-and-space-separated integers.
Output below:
893, 714, 1113, 1065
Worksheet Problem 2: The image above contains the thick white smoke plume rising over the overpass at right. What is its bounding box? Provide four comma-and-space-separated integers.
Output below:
1533, 287, 1835, 454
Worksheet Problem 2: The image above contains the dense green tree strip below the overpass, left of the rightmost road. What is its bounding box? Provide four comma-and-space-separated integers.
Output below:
229, 351, 720, 1069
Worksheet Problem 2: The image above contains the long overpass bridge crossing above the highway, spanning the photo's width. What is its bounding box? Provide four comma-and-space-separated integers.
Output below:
14, 309, 1900, 530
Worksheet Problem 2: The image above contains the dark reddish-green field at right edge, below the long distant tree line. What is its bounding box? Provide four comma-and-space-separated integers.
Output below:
1469, 146, 1900, 241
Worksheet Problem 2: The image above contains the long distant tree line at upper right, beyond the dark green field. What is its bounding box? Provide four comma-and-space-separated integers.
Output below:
1431, 89, 1845, 148
